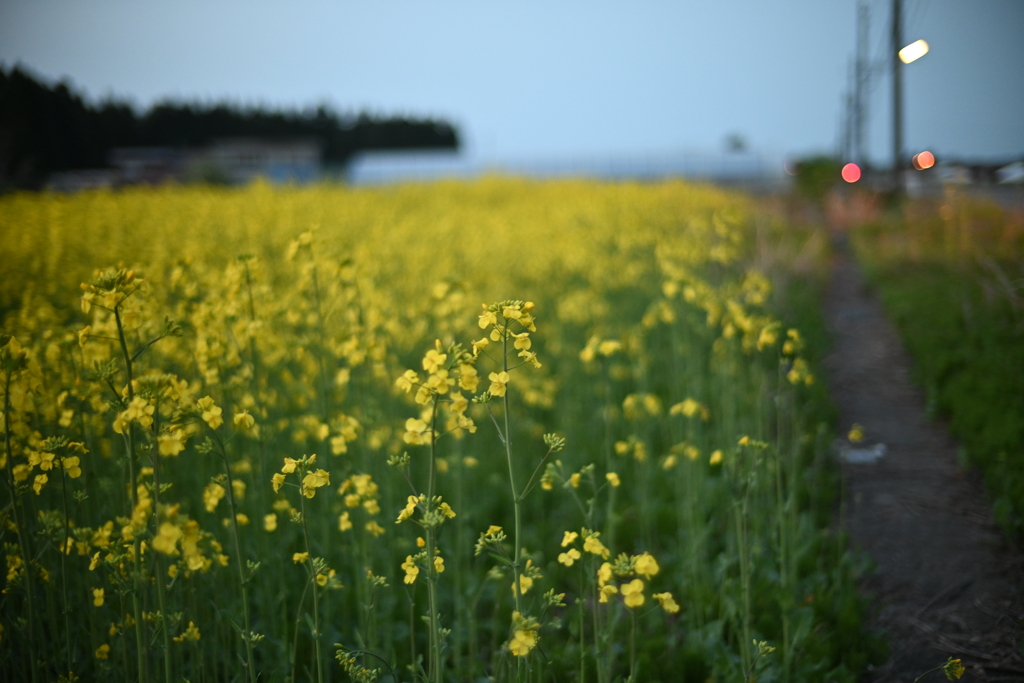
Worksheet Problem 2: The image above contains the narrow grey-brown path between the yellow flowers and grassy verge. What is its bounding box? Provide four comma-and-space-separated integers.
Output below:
826, 245, 1024, 682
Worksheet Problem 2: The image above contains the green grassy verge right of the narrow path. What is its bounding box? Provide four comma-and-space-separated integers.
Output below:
854, 200, 1024, 538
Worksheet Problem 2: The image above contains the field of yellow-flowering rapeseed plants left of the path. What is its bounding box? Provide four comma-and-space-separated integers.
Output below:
0, 177, 867, 683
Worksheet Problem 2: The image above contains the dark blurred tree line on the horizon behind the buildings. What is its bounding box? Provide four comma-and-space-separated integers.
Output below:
0, 67, 459, 190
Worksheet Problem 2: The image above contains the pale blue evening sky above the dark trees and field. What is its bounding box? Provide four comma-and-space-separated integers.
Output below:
0, 0, 1024, 161
